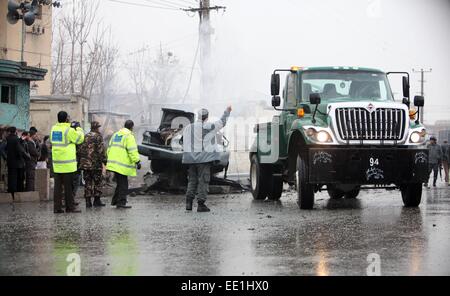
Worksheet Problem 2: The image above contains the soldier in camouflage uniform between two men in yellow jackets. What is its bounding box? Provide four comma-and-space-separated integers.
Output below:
79, 121, 106, 208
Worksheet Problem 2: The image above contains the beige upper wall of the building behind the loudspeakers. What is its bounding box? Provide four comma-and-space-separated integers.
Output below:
0, 0, 52, 95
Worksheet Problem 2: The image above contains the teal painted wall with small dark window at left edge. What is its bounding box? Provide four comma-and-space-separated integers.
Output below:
0, 77, 30, 130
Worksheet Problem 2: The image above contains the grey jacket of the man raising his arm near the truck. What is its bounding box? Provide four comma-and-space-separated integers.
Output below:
183, 111, 230, 164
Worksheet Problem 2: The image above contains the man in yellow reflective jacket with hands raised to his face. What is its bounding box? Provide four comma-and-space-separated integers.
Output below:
50, 111, 84, 214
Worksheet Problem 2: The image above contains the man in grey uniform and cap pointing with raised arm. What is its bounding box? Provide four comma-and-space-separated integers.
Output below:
182, 106, 231, 212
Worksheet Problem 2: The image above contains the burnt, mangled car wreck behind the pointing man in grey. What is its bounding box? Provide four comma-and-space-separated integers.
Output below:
138, 108, 243, 191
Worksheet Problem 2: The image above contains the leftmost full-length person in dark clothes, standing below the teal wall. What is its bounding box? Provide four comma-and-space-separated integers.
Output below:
6, 126, 30, 199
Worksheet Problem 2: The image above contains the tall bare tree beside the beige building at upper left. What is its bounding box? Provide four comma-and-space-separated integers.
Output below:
52, 0, 118, 109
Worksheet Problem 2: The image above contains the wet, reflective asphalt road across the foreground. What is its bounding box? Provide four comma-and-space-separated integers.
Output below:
0, 185, 450, 275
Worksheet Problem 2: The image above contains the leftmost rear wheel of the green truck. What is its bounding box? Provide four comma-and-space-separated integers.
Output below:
250, 155, 270, 200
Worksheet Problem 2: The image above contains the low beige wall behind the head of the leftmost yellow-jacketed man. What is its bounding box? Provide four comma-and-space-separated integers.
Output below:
30, 96, 89, 135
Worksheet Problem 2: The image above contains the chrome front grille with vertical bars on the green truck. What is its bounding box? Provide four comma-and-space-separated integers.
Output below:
336, 108, 407, 141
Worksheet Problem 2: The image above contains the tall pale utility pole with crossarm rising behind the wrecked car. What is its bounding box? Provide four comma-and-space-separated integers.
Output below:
183, 0, 226, 102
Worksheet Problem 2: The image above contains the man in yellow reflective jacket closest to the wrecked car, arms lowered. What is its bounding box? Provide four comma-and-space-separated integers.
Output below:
106, 120, 141, 209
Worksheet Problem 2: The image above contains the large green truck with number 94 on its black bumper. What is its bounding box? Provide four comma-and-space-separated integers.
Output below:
250, 67, 428, 209
